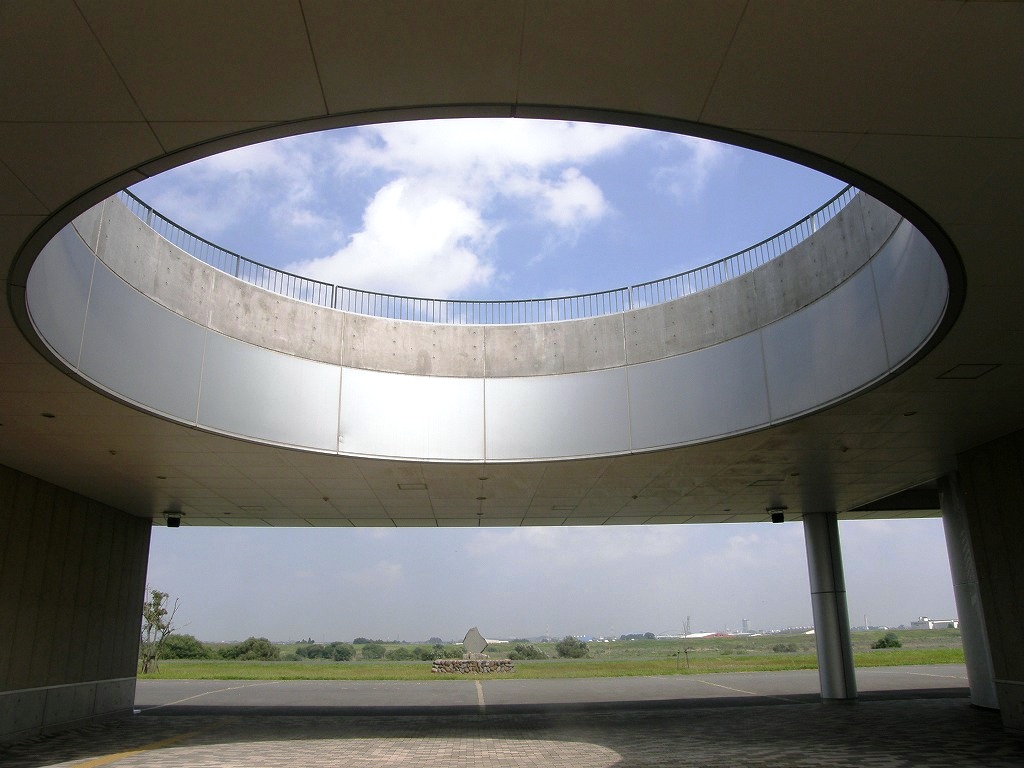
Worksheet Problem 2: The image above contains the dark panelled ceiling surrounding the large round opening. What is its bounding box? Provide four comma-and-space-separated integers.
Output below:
0, 0, 1024, 525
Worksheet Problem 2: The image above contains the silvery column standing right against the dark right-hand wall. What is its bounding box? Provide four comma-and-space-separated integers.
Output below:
939, 474, 999, 710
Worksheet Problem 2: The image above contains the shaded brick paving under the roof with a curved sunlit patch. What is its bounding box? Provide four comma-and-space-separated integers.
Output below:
0, 696, 1024, 768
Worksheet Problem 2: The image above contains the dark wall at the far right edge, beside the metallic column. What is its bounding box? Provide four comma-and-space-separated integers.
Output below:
958, 432, 1024, 732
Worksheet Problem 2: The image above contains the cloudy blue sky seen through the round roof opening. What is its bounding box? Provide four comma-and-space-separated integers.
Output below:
125, 118, 844, 300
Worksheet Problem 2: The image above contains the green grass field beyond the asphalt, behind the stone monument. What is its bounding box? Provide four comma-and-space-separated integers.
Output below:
139, 630, 964, 680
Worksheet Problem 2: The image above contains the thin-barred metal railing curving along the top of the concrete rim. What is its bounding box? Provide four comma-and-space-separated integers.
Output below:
118, 186, 858, 325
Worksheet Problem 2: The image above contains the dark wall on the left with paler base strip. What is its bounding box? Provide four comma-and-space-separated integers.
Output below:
0, 466, 152, 741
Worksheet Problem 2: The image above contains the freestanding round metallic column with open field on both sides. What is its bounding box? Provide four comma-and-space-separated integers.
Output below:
804, 512, 857, 701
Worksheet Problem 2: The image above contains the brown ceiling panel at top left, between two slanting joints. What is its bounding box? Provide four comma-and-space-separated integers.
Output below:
78, 0, 326, 124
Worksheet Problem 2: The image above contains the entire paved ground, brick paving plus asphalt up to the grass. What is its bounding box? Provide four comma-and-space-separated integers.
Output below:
0, 667, 1024, 768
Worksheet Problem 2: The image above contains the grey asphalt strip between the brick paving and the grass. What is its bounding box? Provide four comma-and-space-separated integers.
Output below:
135, 665, 967, 715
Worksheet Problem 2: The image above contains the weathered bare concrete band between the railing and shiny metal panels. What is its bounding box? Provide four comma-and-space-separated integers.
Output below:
90, 195, 900, 378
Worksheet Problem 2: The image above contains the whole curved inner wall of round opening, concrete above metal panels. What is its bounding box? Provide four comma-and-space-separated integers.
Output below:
28, 196, 947, 462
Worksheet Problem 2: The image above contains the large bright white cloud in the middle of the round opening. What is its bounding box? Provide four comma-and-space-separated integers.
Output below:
288, 120, 637, 297
